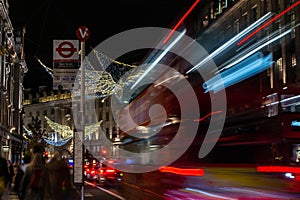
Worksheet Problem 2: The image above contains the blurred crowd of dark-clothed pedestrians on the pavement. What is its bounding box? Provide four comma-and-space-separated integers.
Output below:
0, 145, 80, 200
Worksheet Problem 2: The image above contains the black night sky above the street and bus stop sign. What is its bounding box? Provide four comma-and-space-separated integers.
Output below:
9, 0, 194, 92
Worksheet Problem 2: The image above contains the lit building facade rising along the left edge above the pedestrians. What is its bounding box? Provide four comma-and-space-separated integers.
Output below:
0, 0, 27, 163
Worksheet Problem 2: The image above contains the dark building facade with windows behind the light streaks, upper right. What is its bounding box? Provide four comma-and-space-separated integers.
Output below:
191, 0, 300, 90
